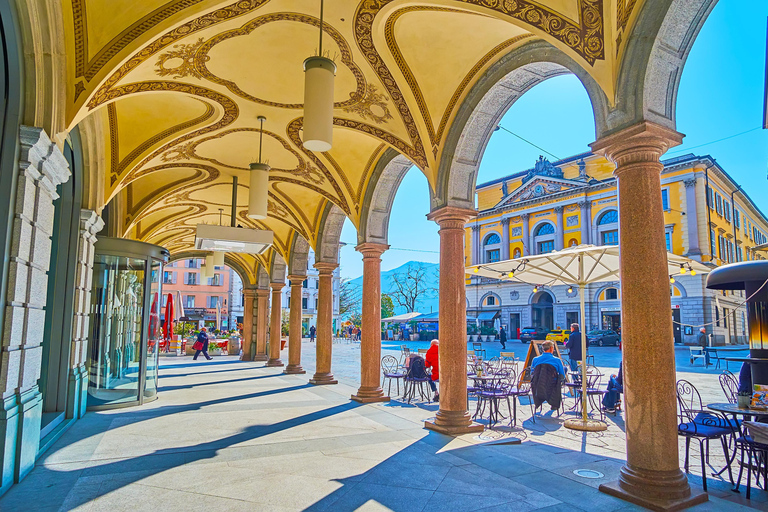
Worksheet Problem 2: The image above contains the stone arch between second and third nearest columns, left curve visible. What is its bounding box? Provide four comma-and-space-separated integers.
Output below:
357, 148, 413, 244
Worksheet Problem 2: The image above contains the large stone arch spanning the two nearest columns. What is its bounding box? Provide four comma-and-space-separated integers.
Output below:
431, 37, 608, 211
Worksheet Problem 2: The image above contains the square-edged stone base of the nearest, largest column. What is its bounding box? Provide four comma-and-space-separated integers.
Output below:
600, 466, 709, 512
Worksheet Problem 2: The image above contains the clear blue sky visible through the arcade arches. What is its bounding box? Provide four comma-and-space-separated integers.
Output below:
341, 0, 768, 278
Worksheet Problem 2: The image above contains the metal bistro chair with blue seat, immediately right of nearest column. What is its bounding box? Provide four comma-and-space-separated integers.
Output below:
677, 380, 735, 491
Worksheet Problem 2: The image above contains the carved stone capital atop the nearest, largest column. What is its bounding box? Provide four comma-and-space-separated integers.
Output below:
590, 121, 684, 167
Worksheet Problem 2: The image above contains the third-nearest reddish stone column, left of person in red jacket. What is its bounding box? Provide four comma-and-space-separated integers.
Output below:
352, 243, 389, 403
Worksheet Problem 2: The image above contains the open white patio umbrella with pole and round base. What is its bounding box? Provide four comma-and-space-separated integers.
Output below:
466, 245, 709, 430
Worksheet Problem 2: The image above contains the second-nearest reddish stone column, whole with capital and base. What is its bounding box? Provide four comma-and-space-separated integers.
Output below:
424, 206, 483, 435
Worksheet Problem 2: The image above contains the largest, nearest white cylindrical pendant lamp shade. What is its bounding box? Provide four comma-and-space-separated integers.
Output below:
304, 57, 336, 152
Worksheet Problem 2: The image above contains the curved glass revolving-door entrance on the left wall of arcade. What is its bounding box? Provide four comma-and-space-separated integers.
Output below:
87, 237, 168, 409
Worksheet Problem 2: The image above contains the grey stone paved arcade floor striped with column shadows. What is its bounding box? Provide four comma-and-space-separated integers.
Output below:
0, 342, 768, 512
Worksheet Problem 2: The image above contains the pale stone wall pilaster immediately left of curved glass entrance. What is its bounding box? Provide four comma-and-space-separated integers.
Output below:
66, 210, 104, 418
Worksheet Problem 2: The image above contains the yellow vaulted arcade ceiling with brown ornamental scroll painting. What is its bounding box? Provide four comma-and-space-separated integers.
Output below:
62, 0, 641, 280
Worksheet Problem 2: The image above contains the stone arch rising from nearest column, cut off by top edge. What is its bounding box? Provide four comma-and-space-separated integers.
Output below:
598, 0, 717, 138
